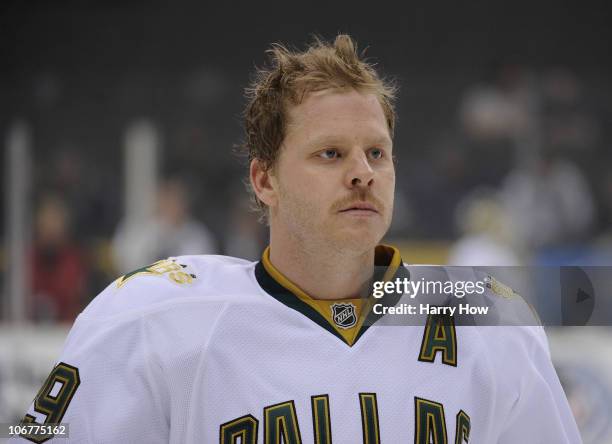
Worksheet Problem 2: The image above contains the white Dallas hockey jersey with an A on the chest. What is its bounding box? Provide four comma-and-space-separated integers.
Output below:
15, 247, 581, 444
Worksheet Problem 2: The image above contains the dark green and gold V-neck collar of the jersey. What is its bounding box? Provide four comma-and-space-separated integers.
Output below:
255, 245, 410, 346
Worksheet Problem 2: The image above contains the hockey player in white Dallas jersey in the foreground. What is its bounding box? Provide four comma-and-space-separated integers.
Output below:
11, 35, 580, 444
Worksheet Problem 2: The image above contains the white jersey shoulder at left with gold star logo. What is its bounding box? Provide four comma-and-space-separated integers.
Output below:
80, 255, 257, 319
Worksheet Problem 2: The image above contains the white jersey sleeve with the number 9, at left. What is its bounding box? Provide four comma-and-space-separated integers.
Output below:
11, 284, 169, 443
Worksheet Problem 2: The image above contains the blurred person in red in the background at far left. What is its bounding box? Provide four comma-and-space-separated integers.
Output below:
30, 194, 88, 322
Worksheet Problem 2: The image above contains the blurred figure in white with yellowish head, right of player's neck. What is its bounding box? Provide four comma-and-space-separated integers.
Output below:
448, 189, 521, 266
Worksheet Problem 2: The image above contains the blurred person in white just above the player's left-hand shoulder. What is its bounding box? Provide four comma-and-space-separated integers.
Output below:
113, 178, 217, 273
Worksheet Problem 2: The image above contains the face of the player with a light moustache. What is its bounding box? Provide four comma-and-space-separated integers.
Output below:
269, 89, 395, 252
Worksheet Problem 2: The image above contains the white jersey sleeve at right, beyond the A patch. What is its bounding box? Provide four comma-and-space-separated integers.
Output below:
497, 327, 582, 444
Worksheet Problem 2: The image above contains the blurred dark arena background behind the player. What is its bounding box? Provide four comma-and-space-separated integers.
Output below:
0, 0, 612, 443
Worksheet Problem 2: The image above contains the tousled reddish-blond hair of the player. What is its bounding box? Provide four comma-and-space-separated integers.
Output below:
243, 34, 397, 215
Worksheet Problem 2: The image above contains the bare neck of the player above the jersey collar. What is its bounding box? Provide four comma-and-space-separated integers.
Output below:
270, 232, 374, 299
